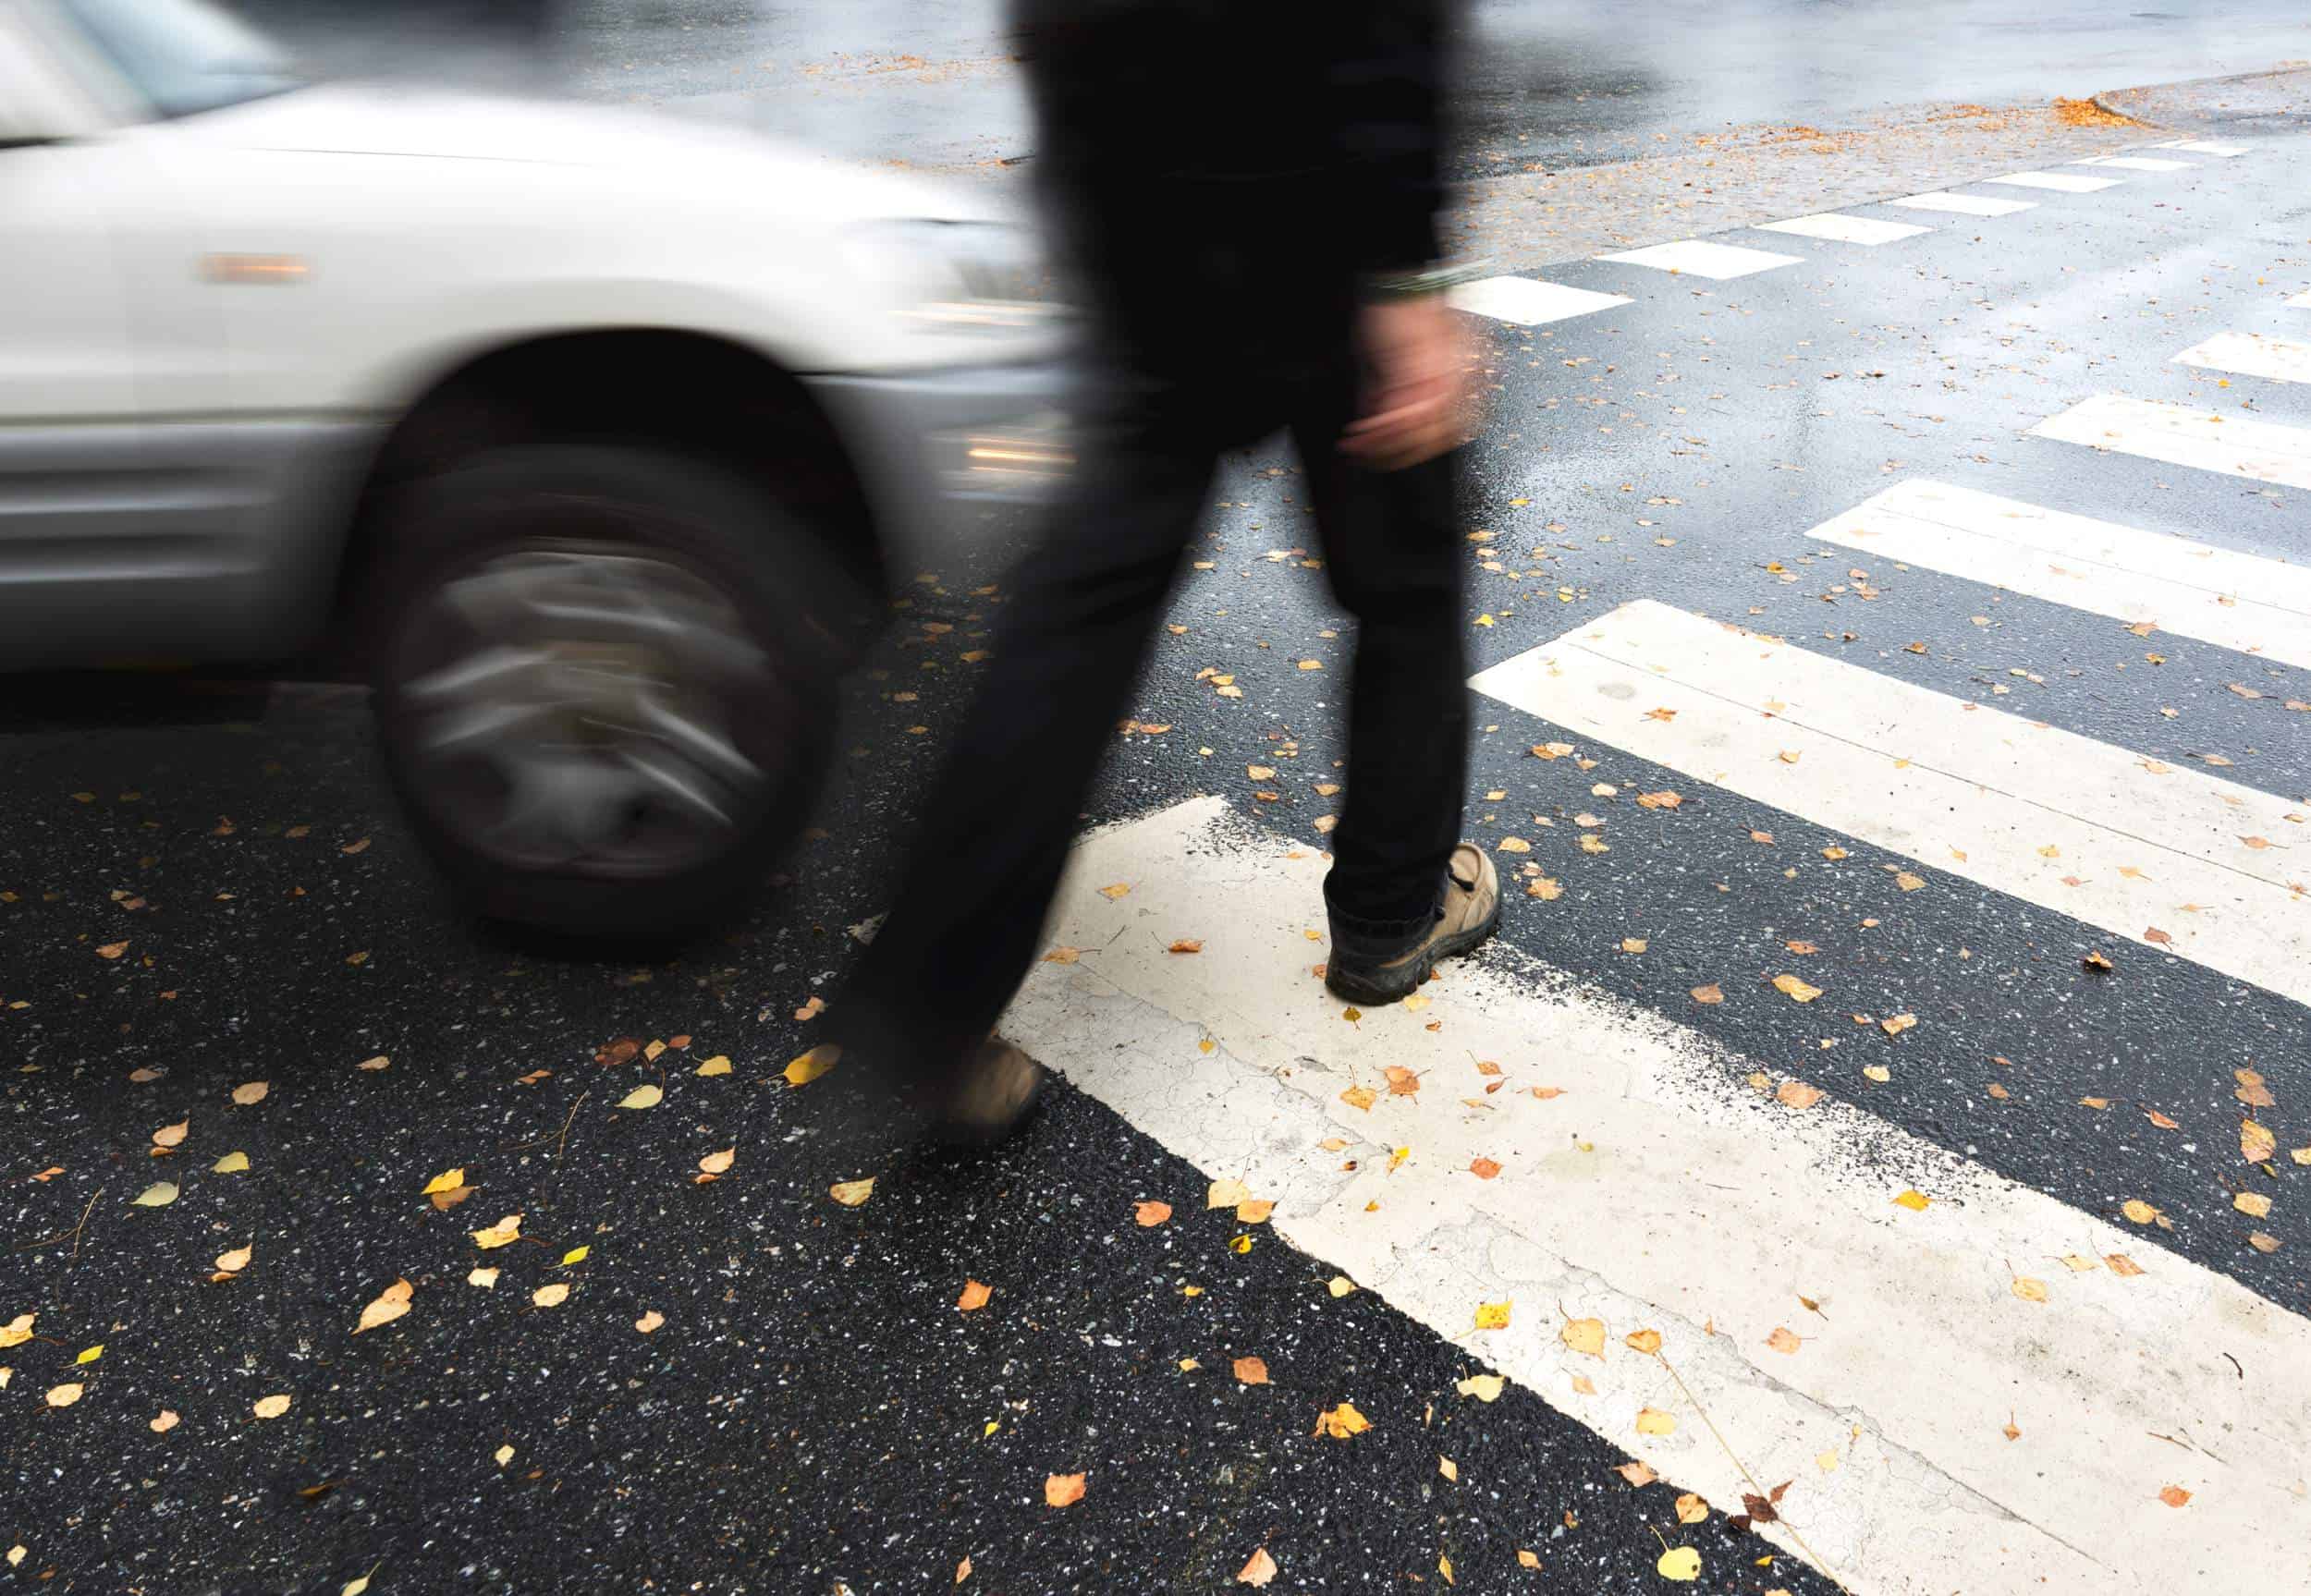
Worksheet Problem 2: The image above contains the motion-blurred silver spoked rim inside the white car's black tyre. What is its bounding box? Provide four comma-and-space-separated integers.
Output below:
400, 547, 772, 875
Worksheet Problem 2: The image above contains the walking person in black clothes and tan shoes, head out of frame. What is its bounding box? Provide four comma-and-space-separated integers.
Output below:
837, 0, 1500, 1141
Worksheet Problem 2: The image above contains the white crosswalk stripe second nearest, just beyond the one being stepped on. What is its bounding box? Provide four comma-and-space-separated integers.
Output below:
1470, 601, 2311, 1003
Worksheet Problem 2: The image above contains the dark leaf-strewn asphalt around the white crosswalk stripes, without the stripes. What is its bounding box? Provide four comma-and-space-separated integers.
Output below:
0, 18, 2311, 1596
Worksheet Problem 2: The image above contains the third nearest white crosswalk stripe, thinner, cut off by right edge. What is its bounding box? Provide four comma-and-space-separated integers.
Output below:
1805, 478, 2311, 674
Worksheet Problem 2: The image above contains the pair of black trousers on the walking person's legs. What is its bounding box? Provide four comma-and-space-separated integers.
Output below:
839, 348, 1468, 1086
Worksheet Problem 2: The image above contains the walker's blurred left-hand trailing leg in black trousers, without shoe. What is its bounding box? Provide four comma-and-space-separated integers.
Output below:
835, 396, 1216, 1114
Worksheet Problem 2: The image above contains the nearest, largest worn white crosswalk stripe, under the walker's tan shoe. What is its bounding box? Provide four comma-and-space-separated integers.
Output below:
1021, 799, 2311, 1596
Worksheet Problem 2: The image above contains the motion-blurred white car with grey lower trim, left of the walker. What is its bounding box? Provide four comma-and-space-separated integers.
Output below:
0, 0, 1066, 933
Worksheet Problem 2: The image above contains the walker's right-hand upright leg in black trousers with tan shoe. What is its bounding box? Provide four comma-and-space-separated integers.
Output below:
1292, 360, 1498, 993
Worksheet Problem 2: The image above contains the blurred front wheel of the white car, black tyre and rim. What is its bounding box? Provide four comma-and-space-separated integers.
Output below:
374, 445, 835, 940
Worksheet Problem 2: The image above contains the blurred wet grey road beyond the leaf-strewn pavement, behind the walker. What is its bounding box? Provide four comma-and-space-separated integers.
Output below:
236, 0, 2311, 177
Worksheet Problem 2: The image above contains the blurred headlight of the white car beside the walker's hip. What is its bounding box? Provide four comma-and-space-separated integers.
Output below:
849, 219, 1063, 333
